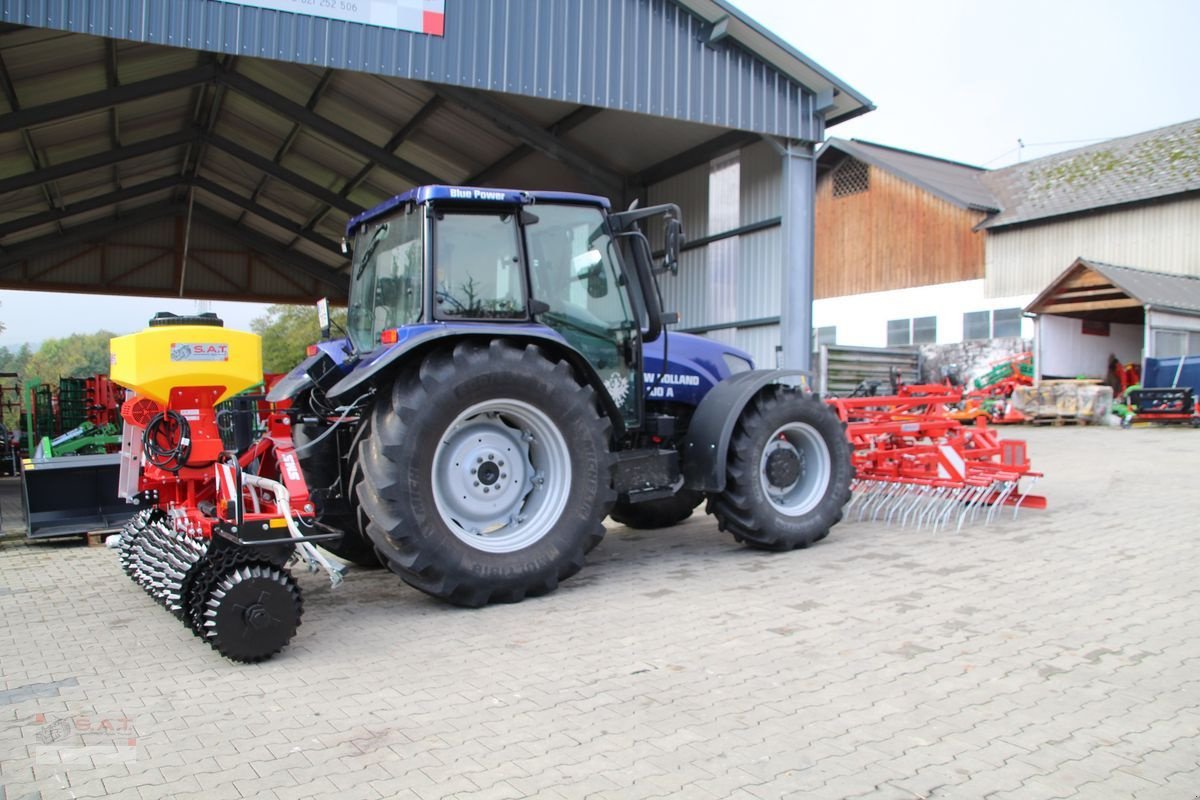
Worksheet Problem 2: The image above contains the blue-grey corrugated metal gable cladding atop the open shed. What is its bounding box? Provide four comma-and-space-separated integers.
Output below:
0, 0, 872, 142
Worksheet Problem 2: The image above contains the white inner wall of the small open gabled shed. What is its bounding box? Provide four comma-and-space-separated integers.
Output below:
1037, 314, 1145, 378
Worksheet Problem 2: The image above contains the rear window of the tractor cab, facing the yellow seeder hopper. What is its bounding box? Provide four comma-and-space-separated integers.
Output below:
347, 210, 424, 353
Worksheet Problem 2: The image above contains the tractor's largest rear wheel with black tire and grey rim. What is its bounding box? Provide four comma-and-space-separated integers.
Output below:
358, 339, 616, 607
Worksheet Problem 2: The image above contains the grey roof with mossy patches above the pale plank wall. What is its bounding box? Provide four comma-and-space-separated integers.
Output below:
980, 120, 1200, 228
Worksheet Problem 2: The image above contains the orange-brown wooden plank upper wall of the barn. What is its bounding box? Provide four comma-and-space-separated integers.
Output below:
814, 167, 984, 299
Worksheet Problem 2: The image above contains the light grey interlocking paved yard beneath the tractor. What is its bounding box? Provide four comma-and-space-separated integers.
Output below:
0, 428, 1200, 800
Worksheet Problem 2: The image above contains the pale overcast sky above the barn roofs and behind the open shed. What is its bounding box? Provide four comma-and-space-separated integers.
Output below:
0, 0, 1200, 348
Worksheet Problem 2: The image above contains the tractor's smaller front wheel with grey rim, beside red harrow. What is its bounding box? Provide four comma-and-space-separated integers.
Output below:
708, 386, 854, 551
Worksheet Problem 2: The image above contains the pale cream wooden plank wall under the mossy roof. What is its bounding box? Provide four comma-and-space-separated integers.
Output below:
984, 197, 1200, 297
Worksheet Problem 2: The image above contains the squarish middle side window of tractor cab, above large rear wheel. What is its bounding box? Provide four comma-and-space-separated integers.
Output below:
433, 211, 526, 319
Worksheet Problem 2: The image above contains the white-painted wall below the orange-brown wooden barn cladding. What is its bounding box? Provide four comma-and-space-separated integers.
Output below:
812, 279, 1034, 347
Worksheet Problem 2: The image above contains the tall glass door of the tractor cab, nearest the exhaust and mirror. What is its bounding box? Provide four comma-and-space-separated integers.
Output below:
526, 204, 640, 423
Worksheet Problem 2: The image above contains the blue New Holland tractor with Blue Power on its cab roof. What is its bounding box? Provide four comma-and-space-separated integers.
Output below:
270, 186, 853, 607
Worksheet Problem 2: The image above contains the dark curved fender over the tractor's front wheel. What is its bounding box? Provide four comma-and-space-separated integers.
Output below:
679, 369, 812, 492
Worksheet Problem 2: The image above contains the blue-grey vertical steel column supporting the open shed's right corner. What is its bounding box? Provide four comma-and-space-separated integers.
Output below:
767, 138, 817, 369
